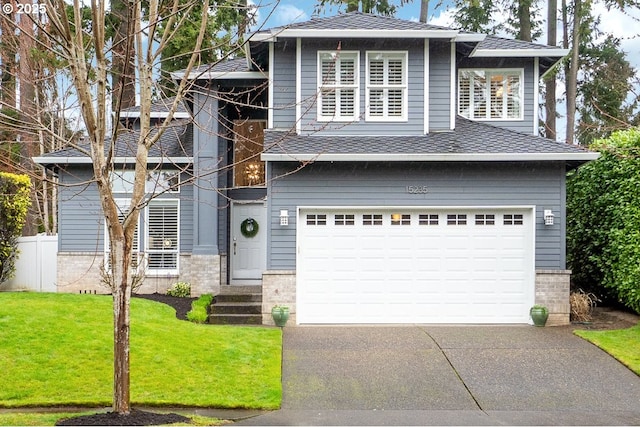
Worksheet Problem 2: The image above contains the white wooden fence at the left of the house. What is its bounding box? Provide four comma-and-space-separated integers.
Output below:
0, 235, 58, 292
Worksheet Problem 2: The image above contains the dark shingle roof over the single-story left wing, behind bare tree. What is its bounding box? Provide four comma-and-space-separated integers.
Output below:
42, 120, 193, 163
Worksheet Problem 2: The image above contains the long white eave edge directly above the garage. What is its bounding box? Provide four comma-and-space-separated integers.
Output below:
260, 152, 600, 162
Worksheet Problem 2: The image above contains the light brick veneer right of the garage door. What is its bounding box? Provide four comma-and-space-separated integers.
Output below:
535, 270, 571, 326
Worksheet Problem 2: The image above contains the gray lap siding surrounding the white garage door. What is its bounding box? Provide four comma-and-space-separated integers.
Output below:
267, 162, 565, 270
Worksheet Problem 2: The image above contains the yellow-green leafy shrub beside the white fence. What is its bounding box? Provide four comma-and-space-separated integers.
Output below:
0, 172, 31, 284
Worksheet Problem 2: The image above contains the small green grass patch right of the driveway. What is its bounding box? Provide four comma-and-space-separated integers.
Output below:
574, 324, 640, 375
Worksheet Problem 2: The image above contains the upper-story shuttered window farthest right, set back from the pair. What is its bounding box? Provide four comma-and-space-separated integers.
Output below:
458, 69, 524, 120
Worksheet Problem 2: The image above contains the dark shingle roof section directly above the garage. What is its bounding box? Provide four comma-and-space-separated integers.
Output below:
264, 117, 588, 157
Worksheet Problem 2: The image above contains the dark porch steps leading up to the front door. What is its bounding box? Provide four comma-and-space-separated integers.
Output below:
209, 286, 262, 325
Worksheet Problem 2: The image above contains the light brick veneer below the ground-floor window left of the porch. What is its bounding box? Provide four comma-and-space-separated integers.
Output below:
57, 252, 220, 296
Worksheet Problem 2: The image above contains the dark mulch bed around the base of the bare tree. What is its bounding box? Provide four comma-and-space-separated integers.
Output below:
56, 409, 191, 426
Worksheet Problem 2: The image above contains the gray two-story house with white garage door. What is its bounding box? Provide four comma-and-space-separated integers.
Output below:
38, 12, 597, 324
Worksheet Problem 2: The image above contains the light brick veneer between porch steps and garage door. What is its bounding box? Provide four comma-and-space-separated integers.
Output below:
262, 270, 296, 325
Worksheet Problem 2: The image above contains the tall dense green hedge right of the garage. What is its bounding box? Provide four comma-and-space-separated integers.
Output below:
567, 129, 640, 312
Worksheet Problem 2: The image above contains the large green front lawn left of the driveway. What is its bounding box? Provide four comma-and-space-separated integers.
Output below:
0, 292, 282, 409
